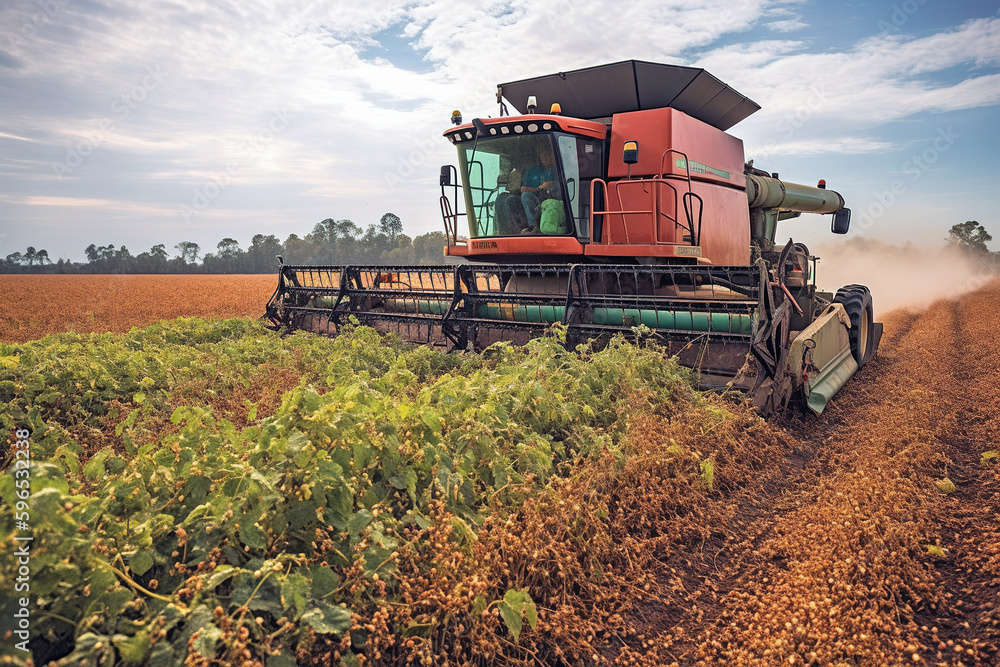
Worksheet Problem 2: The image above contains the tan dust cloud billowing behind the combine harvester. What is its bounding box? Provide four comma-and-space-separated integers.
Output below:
811, 238, 1000, 315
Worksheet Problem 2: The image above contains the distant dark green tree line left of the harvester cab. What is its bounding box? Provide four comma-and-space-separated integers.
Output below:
0, 213, 446, 273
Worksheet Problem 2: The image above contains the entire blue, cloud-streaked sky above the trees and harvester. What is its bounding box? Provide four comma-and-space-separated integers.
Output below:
0, 0, 1000, 261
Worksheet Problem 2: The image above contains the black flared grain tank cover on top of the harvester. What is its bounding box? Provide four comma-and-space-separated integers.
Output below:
499, 60, 760, 130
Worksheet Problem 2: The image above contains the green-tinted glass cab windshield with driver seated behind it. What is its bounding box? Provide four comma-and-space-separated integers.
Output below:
458, 133, 581, 238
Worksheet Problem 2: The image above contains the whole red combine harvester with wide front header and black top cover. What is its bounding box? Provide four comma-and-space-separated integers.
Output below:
267, 60, 882, 414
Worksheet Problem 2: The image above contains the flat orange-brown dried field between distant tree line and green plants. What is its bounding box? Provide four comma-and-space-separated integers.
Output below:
0, 274, 277, 343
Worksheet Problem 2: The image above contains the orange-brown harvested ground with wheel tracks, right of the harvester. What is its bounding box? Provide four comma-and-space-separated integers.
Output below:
620, 283, 1000, 666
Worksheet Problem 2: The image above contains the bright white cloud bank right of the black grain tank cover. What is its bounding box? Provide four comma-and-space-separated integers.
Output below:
703, 19, 1000, 154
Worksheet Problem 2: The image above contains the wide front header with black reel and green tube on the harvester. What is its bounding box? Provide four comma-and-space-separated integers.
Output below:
266, 256, 868, 414
